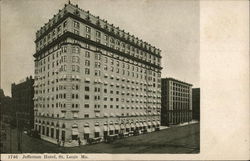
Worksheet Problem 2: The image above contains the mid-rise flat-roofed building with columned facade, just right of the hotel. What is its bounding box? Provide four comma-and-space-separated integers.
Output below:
161, 78, 192, 126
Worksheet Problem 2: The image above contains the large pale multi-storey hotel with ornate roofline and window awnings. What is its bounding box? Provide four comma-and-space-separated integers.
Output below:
34, 2, 162, 146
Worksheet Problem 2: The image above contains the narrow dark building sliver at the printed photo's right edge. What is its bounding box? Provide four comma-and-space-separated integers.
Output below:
192, 88, 200, 121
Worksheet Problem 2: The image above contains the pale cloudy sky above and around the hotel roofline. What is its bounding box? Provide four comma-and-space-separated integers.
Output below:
1, 0, 200, 96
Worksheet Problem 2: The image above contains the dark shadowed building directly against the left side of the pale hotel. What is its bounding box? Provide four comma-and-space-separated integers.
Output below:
11, 76, 34, 130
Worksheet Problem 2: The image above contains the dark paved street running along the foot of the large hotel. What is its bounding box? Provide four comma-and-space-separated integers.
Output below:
4, 123, 200, 153
